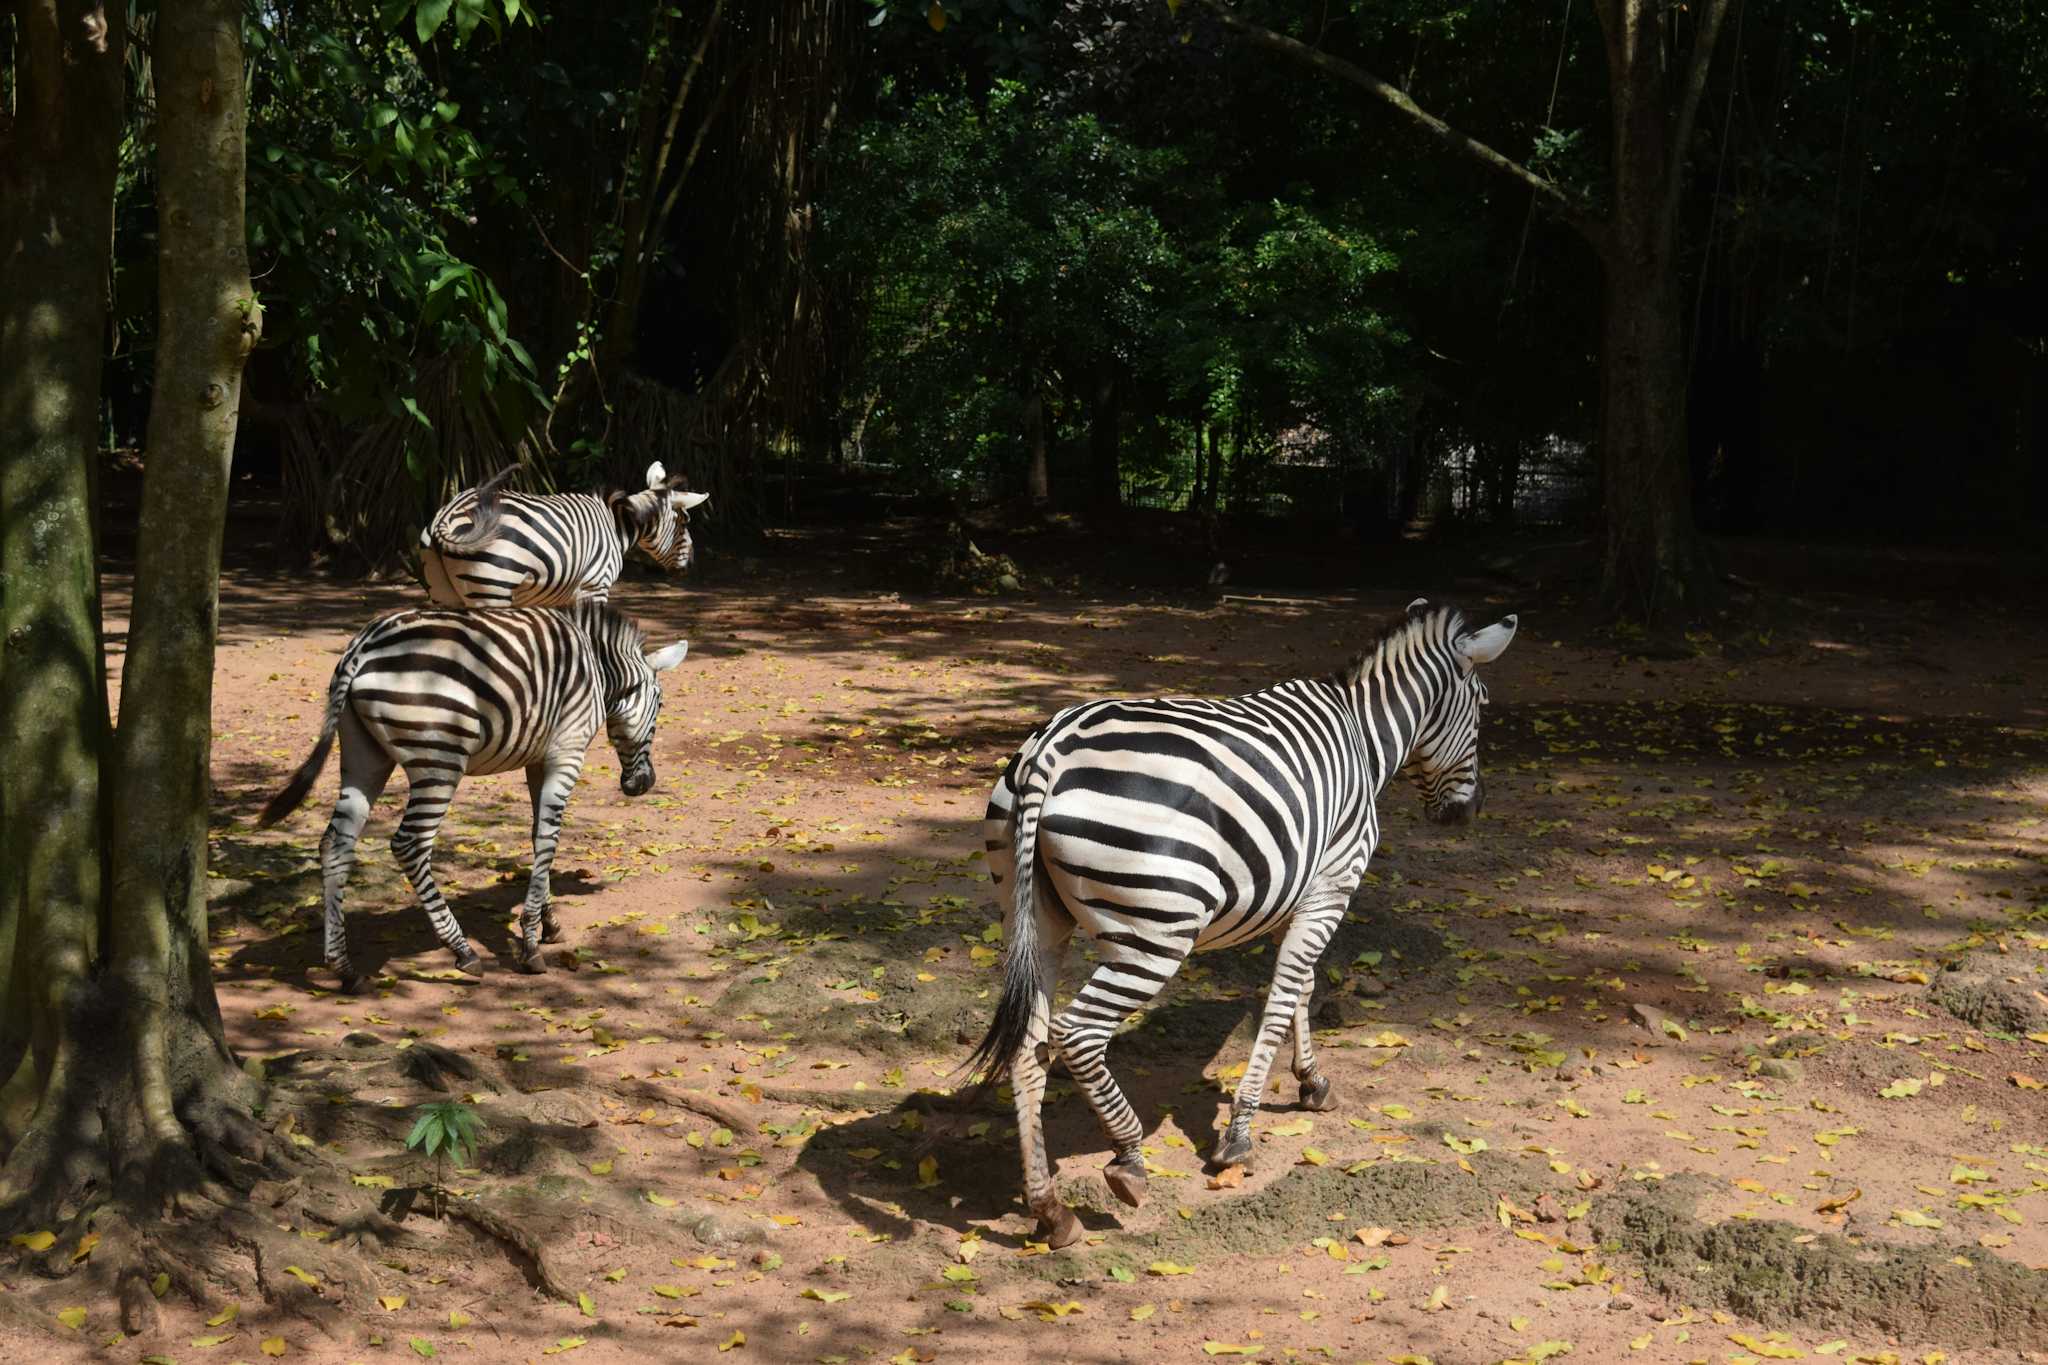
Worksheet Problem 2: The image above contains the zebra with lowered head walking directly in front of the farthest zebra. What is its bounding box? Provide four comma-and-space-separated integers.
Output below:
262, 602, 690, 995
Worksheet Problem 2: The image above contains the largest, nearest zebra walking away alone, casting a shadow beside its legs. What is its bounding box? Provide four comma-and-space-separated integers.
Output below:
969, 600, 1516, 1246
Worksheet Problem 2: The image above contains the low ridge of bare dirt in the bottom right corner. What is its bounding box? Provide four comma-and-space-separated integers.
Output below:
1591, 1177, 2048, 1347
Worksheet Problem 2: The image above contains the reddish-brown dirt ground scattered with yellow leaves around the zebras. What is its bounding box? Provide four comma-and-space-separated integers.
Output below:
0, 540, 2048, 1365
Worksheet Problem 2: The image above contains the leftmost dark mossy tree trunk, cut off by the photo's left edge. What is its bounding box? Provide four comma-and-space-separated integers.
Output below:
0, 0, 125, 1152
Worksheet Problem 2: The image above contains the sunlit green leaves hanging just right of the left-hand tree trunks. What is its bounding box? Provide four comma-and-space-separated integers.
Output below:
248, 0, 545, 458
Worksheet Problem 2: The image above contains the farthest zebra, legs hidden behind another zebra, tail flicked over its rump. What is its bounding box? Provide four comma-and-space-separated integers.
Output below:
420, 463, 711, 606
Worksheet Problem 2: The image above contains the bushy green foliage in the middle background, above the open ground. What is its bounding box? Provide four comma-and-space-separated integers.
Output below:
827, 80, 1403, 507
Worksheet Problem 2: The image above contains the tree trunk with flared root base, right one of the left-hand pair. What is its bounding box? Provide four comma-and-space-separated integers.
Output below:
0, 0, 264, 1277
